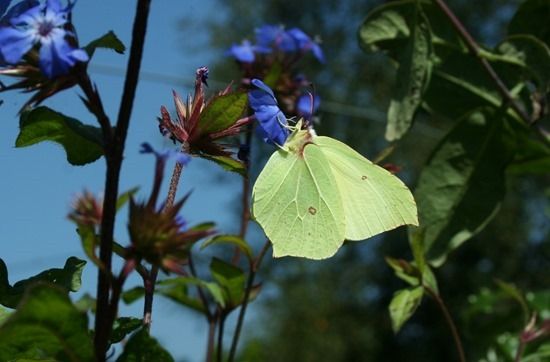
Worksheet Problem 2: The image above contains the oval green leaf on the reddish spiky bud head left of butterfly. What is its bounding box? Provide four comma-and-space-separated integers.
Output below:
198, 92, 248, 134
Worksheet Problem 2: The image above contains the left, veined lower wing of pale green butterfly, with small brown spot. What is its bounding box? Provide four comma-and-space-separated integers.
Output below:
252, 145, 345, 259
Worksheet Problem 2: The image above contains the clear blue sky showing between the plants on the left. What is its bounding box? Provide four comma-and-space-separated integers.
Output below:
0, 0, 258, 361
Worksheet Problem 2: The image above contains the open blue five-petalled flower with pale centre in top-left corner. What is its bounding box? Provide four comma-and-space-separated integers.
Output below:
0, 0, 89, 78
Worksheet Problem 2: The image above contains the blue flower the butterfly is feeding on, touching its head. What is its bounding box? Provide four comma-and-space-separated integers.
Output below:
248, 79, 288, 145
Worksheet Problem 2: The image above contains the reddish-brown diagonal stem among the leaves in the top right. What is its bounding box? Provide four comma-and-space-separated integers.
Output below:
435, 0, 531, 124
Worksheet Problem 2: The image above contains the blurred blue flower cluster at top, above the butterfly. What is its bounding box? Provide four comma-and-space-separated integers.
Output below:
227, 25, 325, 63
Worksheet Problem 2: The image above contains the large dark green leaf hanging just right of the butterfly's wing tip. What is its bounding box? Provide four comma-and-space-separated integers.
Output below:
416, 110, 512, 266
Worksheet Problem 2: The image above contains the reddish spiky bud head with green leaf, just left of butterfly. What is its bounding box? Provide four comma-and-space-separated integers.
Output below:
158, 67, 253, 171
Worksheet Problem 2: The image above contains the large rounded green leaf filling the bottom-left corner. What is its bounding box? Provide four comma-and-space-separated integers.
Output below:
0, 284, 95, 362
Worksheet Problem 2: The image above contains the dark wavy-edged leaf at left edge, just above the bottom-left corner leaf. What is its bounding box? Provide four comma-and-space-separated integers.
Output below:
0, 256, 86, 308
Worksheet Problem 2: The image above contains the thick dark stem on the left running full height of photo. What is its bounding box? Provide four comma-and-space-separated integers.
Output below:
94, 0, 151, 361
